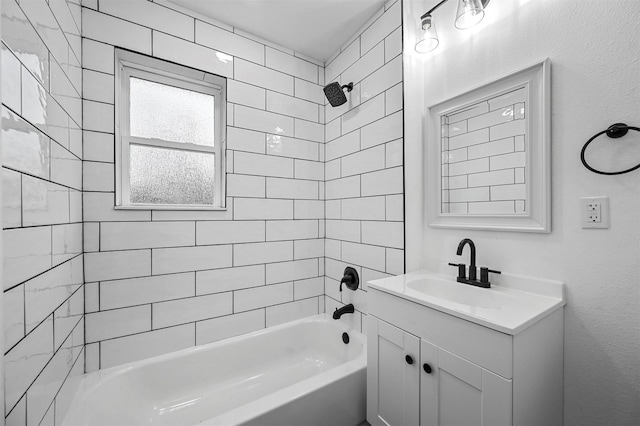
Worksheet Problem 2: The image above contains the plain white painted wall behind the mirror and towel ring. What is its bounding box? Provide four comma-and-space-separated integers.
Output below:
404, 0, 640, 425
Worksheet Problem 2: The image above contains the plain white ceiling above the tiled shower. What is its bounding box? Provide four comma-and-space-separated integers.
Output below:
171, 0, 385, 62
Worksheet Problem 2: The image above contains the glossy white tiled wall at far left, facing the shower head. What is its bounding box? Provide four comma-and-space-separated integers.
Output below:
2, 0, 84, 425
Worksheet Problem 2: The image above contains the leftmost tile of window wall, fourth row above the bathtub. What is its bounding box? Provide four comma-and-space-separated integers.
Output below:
84, 250, 151, 282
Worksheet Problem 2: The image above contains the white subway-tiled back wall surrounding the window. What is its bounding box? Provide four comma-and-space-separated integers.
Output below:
82, 0, 324, 371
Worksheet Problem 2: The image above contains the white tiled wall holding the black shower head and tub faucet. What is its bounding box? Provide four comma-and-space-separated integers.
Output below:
325, 0, 404, 331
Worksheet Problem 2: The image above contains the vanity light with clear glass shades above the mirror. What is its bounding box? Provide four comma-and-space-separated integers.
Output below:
415, 0, 489, 53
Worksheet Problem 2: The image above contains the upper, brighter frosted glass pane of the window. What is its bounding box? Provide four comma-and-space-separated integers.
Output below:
129, 77, 214, 146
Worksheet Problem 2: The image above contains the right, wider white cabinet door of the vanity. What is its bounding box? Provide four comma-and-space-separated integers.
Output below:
420, 340, 512, 426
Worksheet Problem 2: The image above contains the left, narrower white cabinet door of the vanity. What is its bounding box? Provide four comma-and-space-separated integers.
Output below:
367, 317, 420, 426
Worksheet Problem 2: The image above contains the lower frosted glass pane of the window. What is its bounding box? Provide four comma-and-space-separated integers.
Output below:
130, 144, 215, 205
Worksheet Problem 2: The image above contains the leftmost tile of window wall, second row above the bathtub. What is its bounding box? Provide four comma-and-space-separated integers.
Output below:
85, 305, 151, 342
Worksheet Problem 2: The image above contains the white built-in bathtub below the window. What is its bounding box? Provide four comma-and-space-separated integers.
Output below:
63, 314, 367, 426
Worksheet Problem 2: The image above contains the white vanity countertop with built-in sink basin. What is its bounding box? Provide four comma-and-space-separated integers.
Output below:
368, 271, 566, 335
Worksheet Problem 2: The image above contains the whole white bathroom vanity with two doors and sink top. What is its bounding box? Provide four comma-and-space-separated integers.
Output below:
367, 271, 565, 426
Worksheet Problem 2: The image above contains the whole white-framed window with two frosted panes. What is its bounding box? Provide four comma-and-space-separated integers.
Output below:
116, 50, 226, 210
